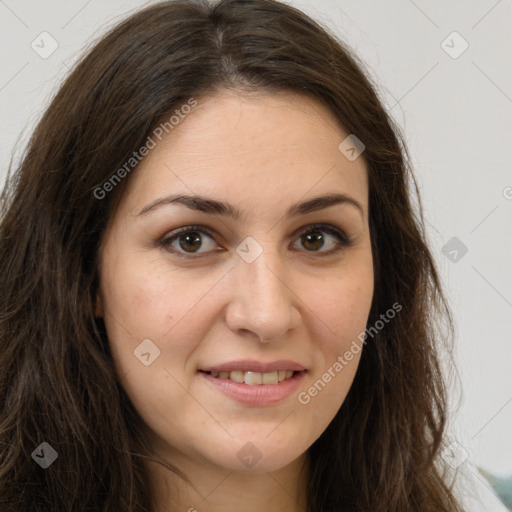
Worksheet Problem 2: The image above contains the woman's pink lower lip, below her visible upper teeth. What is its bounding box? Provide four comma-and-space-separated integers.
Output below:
200, 370, 306, 405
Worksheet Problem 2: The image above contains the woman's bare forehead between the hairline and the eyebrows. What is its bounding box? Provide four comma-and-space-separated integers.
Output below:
121, 93, 367, 219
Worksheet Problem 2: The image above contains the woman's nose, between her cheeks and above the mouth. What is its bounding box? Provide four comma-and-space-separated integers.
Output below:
226, 245, 301, 343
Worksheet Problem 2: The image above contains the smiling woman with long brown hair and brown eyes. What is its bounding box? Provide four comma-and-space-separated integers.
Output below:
0, 0, 480, 512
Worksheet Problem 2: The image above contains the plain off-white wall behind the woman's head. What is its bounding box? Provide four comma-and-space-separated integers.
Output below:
0, 0, 512, 484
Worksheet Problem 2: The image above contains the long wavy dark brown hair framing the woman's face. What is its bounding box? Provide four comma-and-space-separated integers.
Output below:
0, 0, 462, 512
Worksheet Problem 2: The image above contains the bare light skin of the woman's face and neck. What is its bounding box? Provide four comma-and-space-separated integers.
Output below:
96, 92, 373, 512
